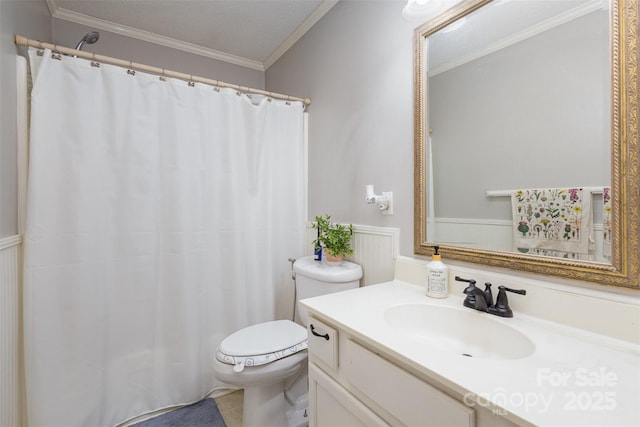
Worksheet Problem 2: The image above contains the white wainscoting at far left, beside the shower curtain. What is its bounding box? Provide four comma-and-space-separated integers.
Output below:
0, 236, 24, 426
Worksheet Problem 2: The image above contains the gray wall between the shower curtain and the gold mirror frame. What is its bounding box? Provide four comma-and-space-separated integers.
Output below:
266, 0, 414, 255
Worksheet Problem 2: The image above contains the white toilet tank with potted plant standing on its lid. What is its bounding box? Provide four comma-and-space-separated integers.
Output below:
293, 256, 362, 326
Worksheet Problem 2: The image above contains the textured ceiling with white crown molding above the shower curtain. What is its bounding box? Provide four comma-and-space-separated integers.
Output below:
47, 0, 337, 69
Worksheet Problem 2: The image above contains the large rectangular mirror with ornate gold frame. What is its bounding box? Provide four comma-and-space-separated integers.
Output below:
414, 0, 640, 288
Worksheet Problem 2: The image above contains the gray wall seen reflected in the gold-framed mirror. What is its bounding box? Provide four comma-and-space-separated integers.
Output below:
428, 10, 611, 220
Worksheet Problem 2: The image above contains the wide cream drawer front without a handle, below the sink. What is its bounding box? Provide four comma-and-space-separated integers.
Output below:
341, 339, 475, 427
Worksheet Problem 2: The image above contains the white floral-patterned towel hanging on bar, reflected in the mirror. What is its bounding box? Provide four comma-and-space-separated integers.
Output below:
511, 188, 592, 258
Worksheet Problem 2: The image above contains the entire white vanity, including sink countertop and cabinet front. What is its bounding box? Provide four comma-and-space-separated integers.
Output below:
300, 281, 640, 427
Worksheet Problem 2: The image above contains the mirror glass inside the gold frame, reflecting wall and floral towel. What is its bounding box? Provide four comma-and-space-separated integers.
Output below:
425, 1, 611, 261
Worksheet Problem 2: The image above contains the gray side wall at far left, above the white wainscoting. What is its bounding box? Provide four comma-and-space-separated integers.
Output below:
0, 0, 51, 238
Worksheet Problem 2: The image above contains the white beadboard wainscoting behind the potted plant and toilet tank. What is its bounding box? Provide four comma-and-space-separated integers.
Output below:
305, 222, 400, 286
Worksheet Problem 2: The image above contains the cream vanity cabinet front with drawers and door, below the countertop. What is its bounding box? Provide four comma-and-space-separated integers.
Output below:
309, 317, 476, 427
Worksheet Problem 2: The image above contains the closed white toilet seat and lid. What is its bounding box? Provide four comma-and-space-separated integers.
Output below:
216, 320, 307, 372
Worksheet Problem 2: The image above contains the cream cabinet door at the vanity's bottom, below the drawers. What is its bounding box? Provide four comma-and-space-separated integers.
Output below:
309, 363, 389, 427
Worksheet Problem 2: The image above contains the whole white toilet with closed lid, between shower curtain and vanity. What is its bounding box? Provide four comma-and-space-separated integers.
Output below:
213, 256, 362, 427
